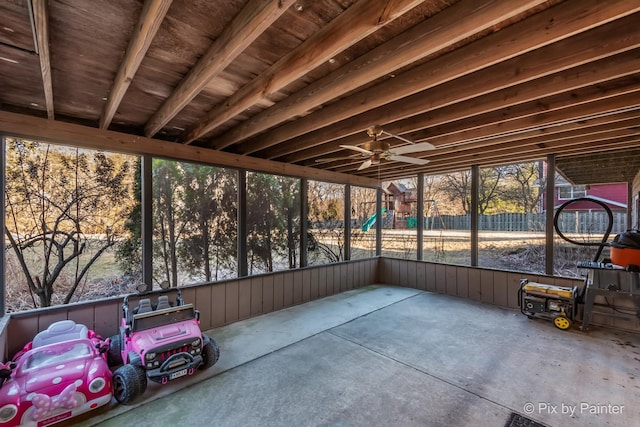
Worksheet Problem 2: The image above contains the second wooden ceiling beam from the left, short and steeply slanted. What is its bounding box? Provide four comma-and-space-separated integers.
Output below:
99, 0, 173, 129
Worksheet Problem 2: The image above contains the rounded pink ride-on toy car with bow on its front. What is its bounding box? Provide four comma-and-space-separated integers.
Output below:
0, 320, 112, 426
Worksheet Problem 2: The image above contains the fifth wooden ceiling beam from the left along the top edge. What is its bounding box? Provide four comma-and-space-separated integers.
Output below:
211, 0, 544, 150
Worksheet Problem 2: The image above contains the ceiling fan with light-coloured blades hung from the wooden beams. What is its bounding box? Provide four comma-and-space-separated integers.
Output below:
316, 125, 435, 171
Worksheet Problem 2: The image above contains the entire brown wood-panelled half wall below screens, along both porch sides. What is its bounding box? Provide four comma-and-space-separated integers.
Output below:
0, 258, 640, 360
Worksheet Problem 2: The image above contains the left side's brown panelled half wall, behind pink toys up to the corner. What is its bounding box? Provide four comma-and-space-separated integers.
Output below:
0, 258, 379, 360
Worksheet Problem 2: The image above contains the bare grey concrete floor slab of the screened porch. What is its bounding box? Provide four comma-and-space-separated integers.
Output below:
69, 286, 640, 427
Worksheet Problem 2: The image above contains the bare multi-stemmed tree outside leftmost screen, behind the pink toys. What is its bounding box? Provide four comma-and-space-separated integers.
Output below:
5, 139, 131, 307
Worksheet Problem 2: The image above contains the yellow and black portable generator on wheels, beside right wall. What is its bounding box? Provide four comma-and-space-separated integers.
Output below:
518, 279, 579, 330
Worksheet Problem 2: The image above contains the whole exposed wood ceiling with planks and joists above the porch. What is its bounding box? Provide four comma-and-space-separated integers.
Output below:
0, 0, 640, 183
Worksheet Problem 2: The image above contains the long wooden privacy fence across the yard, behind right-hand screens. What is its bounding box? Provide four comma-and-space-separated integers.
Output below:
432, 212, 627, 234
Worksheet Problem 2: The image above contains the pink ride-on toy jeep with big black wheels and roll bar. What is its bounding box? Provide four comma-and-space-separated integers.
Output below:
108, 284, 220, 404
